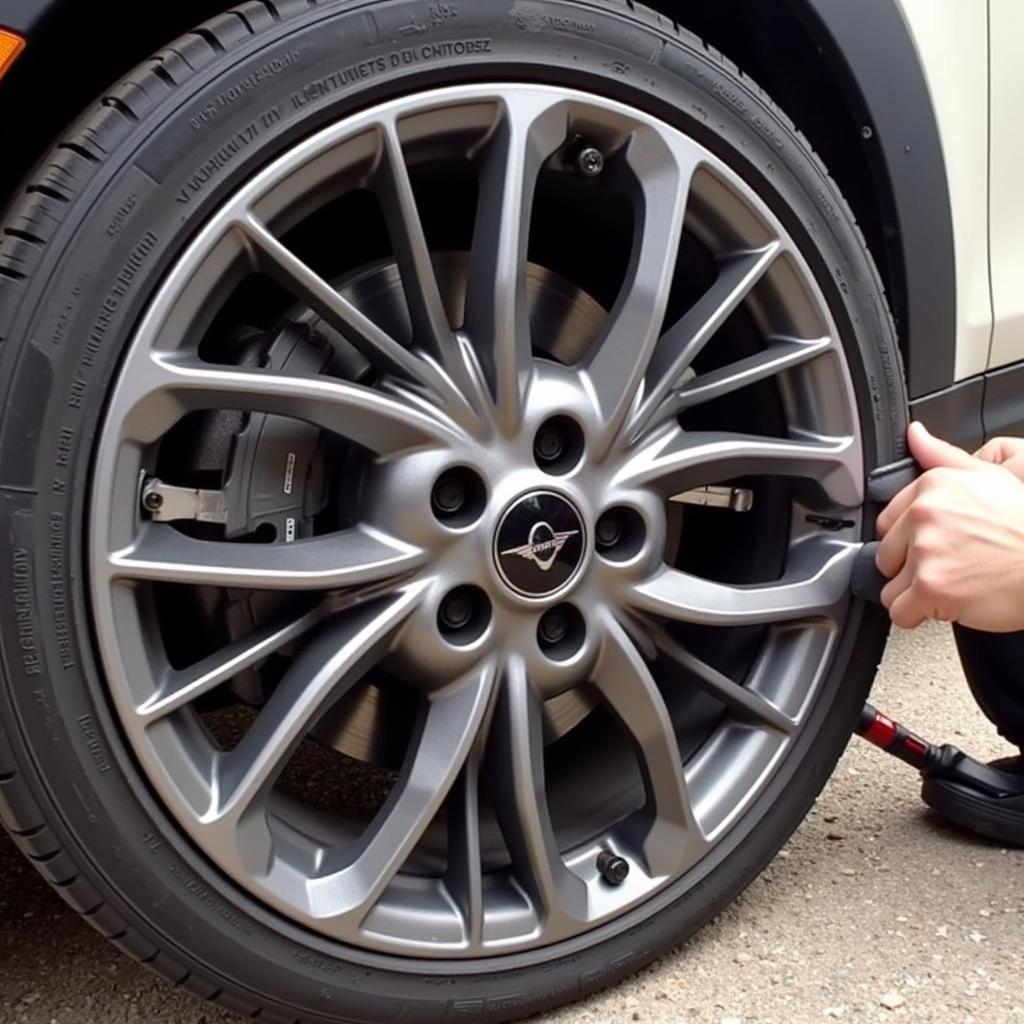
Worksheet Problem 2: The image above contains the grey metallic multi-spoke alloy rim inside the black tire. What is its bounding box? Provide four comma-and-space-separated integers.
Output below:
90, 84, 863, 957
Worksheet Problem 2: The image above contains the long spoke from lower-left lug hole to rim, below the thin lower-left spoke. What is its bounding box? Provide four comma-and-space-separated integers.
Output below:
205, 587, 422, 834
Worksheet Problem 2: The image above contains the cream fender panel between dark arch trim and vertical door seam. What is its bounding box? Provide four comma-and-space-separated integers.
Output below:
900, 0, 991, 380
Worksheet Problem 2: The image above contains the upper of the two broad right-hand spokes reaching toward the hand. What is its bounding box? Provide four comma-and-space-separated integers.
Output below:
618, 426, 864, 508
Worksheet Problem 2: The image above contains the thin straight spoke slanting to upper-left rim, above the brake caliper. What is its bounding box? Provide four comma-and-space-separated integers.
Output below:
236, 214, 453, 398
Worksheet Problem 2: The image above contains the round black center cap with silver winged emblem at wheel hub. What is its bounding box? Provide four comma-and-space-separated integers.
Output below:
495, 490, 587, 597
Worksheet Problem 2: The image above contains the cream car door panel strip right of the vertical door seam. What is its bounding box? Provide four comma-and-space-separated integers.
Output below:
990, 0, 1024, 367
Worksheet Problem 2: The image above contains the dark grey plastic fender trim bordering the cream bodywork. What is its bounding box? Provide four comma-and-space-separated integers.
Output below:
787, 0, 956, 397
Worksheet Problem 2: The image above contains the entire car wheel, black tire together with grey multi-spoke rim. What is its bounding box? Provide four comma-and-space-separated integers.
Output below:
0, 0, 906, 1022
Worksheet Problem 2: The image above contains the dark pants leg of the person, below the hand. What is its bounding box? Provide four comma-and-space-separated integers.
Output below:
953, 626, 1024, 752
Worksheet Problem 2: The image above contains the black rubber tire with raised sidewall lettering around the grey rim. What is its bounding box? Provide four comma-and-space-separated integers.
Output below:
0, 0, 907, 1022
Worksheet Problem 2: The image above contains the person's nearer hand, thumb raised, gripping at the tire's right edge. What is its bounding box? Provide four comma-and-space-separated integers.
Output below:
876, 423, 1024, 633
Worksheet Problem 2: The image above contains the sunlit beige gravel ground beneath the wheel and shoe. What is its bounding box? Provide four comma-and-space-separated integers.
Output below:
0, 627, 1024, 1024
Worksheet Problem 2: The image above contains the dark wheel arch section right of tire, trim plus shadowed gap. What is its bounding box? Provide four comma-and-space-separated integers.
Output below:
645, 0, 957, 398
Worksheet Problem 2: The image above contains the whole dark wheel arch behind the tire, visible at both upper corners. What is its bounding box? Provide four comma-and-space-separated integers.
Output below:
0, 0, 956, 397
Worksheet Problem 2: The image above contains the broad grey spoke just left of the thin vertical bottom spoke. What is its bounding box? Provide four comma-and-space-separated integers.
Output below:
310, 662, 497, 926
